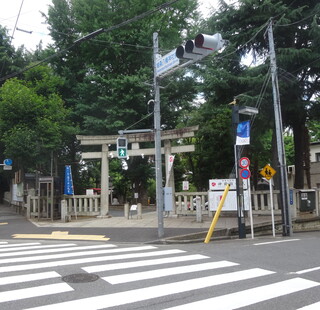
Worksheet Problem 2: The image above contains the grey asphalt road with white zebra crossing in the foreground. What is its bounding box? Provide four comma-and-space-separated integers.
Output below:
0, 232, 320, 310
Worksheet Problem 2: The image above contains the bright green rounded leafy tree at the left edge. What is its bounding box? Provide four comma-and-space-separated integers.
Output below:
0, 66, 74, 173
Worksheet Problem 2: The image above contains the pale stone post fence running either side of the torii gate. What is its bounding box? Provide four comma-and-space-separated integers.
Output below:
24, 189, 320, 220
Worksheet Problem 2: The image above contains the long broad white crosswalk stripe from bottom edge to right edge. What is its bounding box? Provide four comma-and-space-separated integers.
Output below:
166, 278, 320, 310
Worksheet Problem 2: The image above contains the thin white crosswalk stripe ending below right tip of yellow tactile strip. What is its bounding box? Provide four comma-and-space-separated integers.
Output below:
0, 244, 116, 260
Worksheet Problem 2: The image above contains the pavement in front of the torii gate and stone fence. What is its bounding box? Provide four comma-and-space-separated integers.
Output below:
0, 205, 278, 243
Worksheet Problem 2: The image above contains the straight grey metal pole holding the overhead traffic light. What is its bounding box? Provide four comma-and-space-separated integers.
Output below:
153, 32, 164, 238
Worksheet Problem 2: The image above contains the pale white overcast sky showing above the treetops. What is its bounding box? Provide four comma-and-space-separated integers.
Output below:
0, 0, 218, 51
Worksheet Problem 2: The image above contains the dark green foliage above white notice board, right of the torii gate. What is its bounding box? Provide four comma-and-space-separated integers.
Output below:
181, 103, 234, 190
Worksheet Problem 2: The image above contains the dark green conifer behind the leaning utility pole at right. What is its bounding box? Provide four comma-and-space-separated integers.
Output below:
199, 0, 320, 188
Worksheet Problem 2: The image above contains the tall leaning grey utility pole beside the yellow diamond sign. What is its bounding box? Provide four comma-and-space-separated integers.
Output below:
268, 20, 292, 236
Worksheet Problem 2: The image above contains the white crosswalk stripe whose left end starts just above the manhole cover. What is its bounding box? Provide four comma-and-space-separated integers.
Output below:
82, 254, 209, 273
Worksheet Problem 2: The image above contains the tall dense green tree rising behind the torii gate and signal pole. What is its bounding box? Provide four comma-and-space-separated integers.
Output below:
47, 0, 197, 195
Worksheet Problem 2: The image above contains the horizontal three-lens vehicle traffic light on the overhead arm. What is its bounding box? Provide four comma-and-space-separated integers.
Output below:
176, 33, 225, 60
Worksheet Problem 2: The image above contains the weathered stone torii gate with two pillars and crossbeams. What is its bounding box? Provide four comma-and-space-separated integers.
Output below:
76, 126, 199, 216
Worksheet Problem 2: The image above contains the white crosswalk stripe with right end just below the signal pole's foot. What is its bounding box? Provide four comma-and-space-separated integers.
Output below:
0, 245, 156, 264
